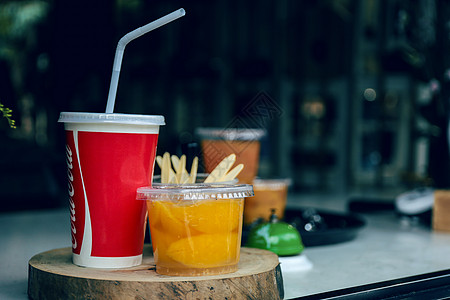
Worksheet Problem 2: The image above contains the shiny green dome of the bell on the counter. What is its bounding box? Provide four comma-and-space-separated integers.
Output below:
246, 210, 304, 256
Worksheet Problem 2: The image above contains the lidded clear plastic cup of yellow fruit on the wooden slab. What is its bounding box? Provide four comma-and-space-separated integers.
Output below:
137, 184, 253, 276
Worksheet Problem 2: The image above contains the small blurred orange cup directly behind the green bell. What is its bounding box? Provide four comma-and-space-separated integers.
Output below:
244, 179, 291, 225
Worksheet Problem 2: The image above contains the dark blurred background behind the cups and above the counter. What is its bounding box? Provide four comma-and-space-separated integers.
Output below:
0, 0, 450, 211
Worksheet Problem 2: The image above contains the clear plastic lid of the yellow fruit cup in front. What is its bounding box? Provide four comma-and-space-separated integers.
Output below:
136, 184, 254, 200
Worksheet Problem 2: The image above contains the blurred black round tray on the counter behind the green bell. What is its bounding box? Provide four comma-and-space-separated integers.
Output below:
283, 208, 366, 247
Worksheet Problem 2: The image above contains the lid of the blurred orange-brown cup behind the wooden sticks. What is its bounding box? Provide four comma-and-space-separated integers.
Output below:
195, 128, 266, 141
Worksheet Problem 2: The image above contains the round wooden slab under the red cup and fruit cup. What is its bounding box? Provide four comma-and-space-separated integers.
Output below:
28, 245, 284, 300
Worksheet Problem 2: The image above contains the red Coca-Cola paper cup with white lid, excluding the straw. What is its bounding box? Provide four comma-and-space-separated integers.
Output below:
58, 112, 164, 268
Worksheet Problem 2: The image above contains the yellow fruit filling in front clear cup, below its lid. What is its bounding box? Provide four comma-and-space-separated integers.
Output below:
147, 198, 244, 276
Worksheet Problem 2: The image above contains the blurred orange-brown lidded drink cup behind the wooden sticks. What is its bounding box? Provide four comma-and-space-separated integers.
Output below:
196, 128, 266, 184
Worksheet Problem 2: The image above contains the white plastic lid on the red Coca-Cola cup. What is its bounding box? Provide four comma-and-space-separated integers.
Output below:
58, 112, 165, 125
